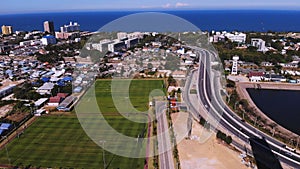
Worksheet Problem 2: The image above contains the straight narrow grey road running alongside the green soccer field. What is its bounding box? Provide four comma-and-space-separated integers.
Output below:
155, 101, 175, 169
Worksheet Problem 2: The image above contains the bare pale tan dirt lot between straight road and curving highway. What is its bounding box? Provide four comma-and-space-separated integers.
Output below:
171, 113, 250, 169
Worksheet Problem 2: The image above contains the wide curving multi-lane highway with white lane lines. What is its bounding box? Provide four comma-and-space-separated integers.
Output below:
185, 48, 300, 168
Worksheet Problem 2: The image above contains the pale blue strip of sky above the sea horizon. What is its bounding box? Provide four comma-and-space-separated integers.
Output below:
0, 0, 300, 14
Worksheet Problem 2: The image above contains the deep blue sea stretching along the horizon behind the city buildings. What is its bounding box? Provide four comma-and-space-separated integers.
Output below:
0, 10, 300, 32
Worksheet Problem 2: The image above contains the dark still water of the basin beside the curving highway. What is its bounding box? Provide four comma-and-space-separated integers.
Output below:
247, 88, 300, 135
